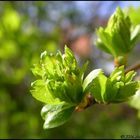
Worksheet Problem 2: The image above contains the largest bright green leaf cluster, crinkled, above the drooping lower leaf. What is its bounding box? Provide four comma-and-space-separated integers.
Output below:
31, 46, 87, 104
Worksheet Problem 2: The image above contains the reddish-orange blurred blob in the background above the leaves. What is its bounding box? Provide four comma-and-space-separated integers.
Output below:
62, 26, 92, 57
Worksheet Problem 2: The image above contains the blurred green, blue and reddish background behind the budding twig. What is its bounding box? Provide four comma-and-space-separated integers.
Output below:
0, 1, 140, 139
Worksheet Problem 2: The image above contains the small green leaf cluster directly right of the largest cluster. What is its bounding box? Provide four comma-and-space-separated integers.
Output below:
86, 66, 139, 103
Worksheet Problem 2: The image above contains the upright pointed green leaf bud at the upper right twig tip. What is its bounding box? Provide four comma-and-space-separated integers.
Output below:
96, 7, 140, 60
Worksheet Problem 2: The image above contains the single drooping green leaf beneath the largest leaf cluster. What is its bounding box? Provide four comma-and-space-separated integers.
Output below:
41, 103, 75, 129
